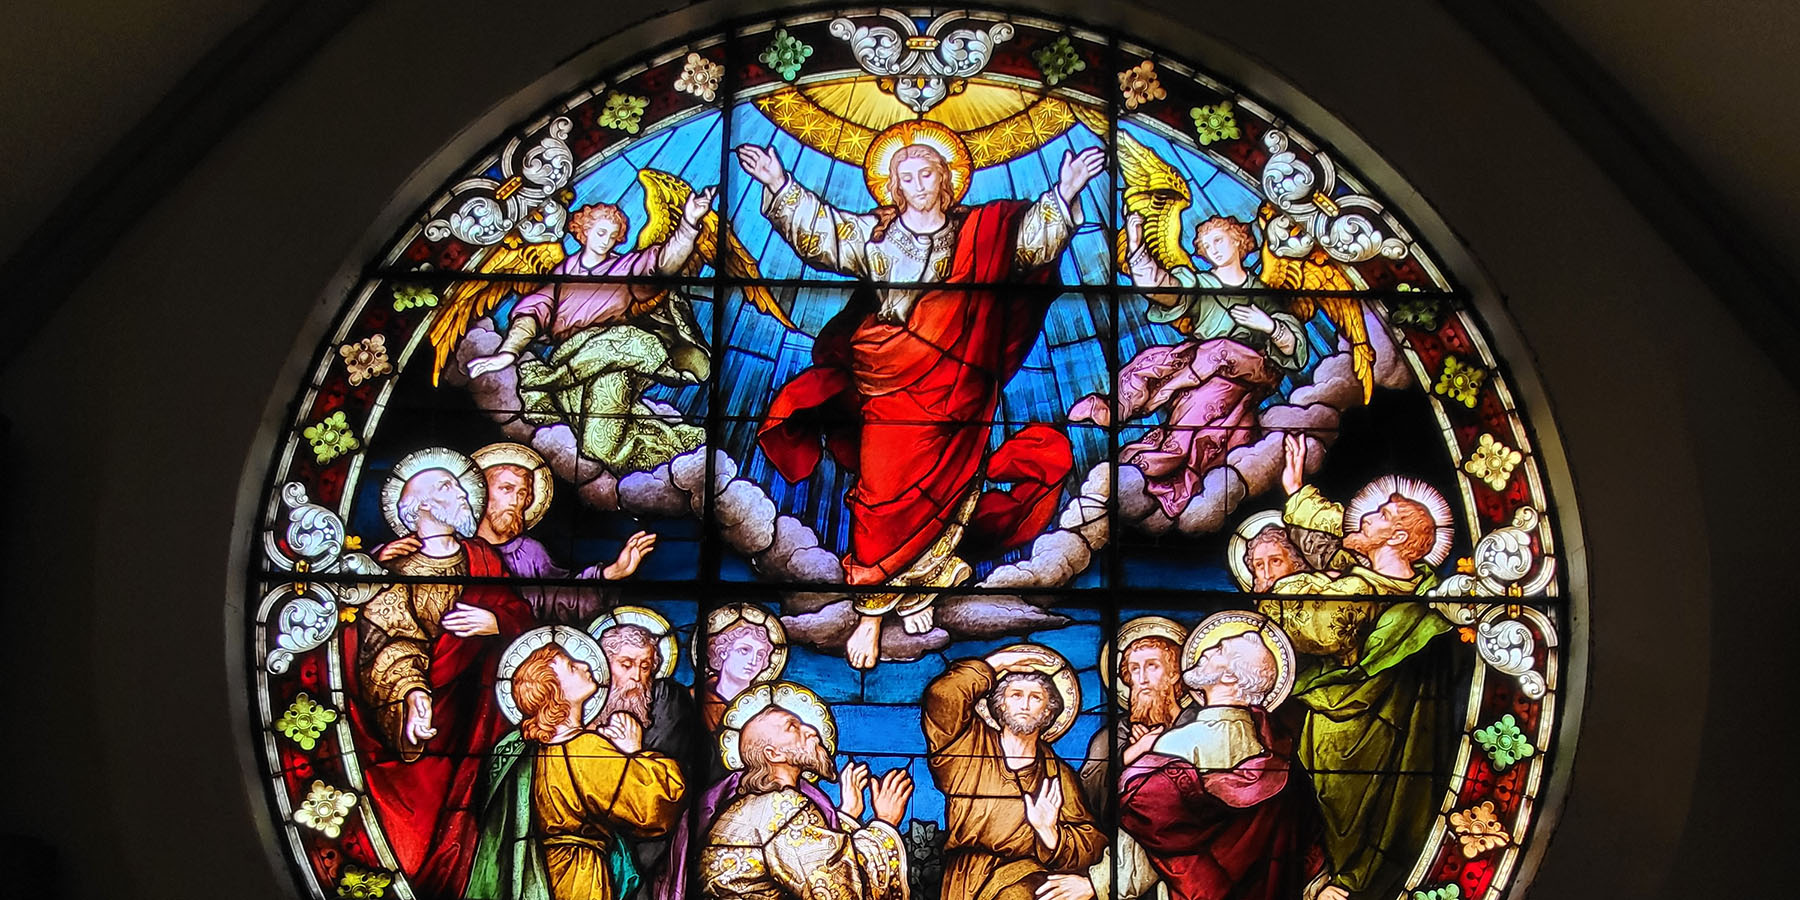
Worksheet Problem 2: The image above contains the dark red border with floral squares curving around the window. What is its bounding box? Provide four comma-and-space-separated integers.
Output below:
250, 13, 1561, 900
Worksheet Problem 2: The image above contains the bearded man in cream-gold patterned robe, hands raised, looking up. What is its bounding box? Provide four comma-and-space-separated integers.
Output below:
700, 706, 913, 900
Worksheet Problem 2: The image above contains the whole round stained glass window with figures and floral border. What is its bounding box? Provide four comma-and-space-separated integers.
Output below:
247, 9, 1570, 900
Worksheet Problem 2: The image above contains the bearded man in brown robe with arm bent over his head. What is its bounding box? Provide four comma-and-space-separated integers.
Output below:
920, 644, 1107, 900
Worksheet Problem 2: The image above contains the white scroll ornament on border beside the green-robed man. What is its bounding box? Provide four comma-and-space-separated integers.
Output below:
1431, 506, 1557, 700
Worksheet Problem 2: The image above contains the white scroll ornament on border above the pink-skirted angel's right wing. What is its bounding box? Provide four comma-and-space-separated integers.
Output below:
1262, 130, 1406, 263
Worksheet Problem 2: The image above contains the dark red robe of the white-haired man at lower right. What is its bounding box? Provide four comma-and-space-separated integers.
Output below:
1120, 709, 1325, 900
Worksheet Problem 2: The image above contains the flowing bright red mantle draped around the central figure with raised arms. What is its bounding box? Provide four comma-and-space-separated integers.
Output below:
758, 200, 1073, 585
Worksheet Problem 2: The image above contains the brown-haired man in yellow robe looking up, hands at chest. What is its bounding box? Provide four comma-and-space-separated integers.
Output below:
513, 643, 686, 900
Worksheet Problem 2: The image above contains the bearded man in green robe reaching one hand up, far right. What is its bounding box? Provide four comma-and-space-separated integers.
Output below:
1258, 436, 1458, 896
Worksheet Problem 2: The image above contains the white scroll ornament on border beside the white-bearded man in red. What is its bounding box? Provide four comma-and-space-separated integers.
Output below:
263, 481, 382, 675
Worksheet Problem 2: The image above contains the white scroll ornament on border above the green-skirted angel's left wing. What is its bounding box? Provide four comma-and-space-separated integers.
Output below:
425, 117, 574, 247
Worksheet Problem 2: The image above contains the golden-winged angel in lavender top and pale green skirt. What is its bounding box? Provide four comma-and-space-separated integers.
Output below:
446, 169, 794, 475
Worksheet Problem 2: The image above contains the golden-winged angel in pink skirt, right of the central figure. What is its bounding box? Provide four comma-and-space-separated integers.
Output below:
1069, 133, 1373, 517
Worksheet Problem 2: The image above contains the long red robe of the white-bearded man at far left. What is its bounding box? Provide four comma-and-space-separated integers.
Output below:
344, 540, 536, 900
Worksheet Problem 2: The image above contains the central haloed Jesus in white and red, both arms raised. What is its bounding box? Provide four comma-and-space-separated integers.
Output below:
736, 121, 1105, 668
